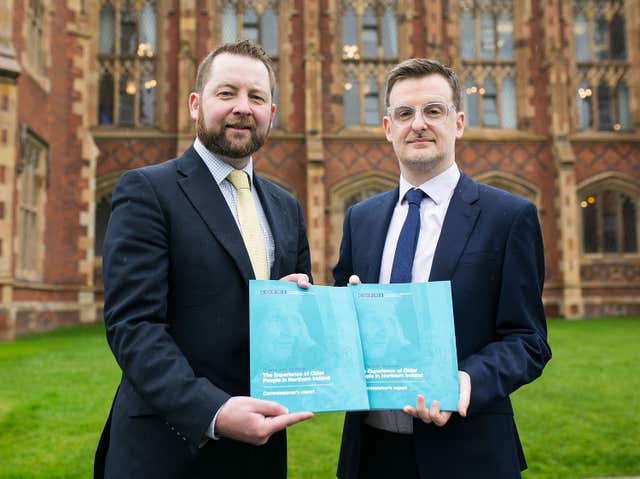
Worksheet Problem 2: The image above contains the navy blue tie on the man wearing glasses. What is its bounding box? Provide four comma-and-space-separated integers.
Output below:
390, 188, 427, 283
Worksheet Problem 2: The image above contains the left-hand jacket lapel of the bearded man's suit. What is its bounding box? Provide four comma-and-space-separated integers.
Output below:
178, 147, 254, 281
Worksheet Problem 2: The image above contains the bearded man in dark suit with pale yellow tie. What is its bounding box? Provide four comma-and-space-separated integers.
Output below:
94, 41, 312, 479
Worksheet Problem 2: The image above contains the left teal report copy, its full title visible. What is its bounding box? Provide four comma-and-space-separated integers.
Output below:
249, 280, 369, 412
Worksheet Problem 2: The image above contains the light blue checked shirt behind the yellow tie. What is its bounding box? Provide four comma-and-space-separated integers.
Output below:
193, 138, 275, 271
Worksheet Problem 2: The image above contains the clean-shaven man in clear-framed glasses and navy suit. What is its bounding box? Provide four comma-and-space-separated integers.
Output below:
334, 59, 551, 479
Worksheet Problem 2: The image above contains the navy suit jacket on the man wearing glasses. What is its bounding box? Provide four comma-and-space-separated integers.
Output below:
334, 174, 551, 479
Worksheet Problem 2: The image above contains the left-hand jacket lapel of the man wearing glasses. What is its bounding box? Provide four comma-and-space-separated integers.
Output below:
359, 187, 400, 283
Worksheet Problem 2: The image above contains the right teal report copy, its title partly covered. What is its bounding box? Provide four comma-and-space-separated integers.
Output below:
348, 281, 458, 411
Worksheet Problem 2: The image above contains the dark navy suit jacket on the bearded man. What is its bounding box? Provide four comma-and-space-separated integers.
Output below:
94, 147, 310, 479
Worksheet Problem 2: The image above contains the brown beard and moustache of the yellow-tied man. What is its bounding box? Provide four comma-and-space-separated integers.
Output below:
196, 109, 269, 159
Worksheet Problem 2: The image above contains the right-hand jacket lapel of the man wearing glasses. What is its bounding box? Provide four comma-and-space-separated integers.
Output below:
429, 173, 480, 281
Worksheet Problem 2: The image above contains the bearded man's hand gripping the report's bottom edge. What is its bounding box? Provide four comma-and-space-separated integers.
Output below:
215, 396, 313, 446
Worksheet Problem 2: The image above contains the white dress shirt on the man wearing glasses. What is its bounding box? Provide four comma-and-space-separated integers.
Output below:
365, 163, 460, 434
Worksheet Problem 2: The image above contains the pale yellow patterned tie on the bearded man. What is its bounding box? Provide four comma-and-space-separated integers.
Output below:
227, 170, 269, 279
